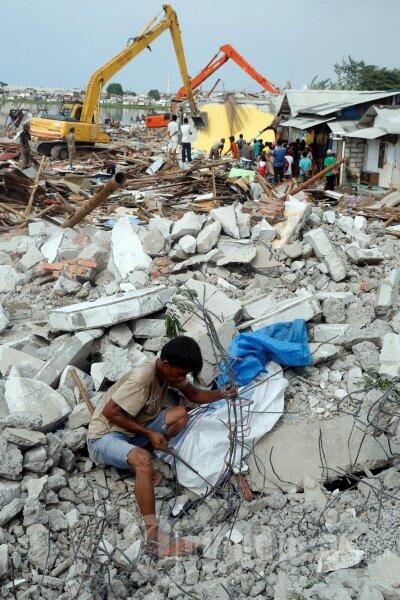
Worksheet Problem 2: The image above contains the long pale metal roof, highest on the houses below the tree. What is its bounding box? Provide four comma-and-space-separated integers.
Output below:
285, 90, 400, 116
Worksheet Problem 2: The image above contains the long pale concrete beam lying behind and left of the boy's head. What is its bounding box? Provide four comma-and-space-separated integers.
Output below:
49, 285, 175, 331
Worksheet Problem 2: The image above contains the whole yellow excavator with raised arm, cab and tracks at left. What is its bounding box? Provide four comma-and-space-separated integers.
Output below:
30, 4, 202, 159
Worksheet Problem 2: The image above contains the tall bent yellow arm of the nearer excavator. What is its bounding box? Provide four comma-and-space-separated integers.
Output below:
80, 4, 197, 123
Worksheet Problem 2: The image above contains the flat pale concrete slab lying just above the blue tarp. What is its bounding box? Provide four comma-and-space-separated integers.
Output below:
238, 292, 321, 331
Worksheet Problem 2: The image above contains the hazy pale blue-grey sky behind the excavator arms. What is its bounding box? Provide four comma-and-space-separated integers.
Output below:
0, 0, 400, 92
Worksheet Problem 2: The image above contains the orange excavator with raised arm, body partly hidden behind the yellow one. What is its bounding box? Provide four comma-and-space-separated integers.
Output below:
146, 44, 279, 128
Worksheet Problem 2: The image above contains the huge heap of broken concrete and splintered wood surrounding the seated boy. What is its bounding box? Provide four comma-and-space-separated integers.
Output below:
0, 129, 400, 600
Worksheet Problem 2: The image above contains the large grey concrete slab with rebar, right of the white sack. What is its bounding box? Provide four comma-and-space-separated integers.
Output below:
248, 415, 400, 492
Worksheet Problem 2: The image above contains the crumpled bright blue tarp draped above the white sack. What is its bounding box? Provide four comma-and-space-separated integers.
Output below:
217, 319, 312, 386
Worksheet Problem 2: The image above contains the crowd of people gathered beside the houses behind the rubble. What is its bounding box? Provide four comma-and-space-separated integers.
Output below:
209, 133, 336, 190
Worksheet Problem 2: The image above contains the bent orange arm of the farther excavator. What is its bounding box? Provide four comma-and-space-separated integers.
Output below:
176, 44, 279, 100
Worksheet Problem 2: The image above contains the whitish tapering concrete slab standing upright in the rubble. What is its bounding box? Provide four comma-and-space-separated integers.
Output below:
108, 216, 152, 280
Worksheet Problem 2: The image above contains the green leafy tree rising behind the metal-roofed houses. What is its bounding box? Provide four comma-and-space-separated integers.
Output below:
335, 56, 400, 91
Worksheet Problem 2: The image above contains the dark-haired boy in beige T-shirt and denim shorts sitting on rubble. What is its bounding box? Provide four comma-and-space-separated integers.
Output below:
88, 336, 236, 556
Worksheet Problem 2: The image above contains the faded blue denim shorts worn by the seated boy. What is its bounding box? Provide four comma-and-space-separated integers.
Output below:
87, 410, 167, 469
